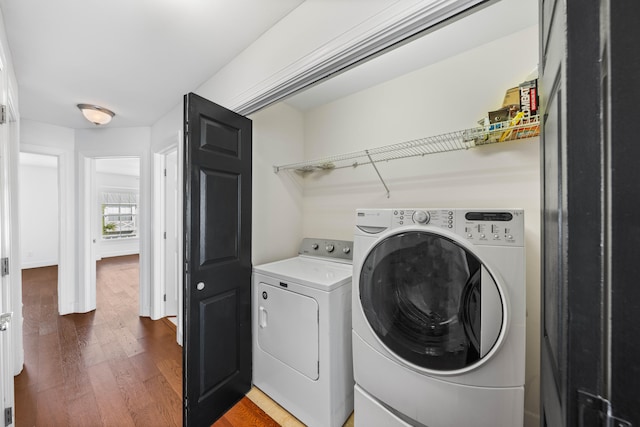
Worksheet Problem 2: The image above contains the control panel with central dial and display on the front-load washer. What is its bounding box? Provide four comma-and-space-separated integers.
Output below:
391, 209, 524, 246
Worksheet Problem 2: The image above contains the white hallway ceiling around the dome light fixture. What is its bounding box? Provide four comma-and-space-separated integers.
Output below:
0, 0, 304, 129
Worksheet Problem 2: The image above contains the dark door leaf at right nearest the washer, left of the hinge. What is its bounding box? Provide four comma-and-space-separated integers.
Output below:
540, 0, 604, 427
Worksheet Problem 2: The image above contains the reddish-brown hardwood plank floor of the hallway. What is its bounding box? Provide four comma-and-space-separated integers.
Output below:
15, 256, 278, 427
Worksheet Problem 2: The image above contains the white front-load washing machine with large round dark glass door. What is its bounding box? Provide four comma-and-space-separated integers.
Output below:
353, 209, 526, 427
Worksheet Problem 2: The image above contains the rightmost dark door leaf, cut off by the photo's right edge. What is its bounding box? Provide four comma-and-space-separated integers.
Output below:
601, 0, 640, 427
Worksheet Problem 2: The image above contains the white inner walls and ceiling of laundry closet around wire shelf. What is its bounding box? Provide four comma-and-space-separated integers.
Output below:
251, 0, 540, 425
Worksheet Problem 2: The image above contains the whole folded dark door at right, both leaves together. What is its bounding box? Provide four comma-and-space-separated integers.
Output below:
540, 0, 640, 427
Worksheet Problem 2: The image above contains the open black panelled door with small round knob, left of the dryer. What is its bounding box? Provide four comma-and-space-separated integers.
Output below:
183, 93, 252, 426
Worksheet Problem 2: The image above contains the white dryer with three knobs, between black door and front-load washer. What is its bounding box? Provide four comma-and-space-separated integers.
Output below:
252, 238, 354, 427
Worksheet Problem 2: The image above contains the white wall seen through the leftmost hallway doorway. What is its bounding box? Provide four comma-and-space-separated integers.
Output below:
19, 164, 59, 268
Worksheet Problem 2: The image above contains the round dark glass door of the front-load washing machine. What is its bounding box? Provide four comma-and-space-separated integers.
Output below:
359, 231, 504, 371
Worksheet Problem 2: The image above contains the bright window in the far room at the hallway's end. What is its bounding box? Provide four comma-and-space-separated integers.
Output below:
101, 192, 138, 239
